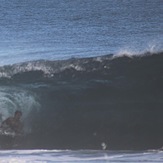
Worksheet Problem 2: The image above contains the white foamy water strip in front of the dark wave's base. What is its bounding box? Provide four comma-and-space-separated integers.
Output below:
0, 150, 163, 163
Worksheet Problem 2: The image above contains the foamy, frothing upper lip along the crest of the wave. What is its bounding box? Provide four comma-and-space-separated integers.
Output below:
0, 52, 162, 78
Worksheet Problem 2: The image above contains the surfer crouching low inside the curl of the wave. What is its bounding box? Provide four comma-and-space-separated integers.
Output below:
1, 110, 23, 134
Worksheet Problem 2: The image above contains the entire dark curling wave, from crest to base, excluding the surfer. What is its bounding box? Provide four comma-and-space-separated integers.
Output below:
0, 52, 163, 149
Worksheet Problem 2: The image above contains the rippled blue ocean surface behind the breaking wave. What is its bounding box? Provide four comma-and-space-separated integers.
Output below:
0, 0, 163, 65
